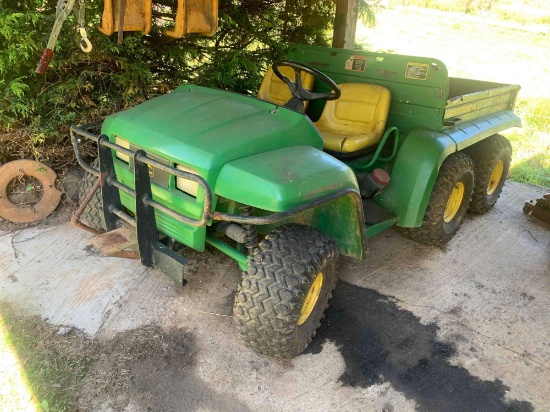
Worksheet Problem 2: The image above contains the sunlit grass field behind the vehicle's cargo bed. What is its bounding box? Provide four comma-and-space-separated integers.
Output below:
356, 0, 550, 187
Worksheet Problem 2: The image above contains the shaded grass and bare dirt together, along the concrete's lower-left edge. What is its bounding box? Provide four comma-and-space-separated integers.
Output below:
0, 303, 248, 412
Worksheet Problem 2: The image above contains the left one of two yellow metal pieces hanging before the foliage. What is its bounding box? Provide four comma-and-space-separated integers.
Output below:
99, 0, 153, 36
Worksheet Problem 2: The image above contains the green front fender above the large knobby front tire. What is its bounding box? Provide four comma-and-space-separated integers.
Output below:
218, 146, 367, 259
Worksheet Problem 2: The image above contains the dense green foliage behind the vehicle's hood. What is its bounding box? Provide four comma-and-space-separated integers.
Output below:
0, 0, 334, 166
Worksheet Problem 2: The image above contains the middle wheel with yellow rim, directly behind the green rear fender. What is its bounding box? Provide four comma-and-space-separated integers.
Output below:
401, 152, 474, 245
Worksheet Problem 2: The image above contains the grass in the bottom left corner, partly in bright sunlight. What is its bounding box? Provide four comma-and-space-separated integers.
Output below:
0, 303, 96, 412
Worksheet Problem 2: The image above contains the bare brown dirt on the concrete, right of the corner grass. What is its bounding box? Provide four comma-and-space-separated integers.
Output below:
78, 325, 254, 412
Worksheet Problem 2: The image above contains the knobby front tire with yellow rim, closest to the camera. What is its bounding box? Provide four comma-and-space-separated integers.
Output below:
233, 224, 338, 358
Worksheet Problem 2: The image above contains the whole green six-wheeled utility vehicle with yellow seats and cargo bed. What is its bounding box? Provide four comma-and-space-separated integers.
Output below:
71, 46, 520, 358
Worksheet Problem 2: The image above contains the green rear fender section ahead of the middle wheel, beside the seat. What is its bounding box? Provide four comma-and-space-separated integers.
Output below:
374, 128, 456, 227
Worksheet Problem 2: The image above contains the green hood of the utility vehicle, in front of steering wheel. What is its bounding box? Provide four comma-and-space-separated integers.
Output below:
103, 85, 323, 184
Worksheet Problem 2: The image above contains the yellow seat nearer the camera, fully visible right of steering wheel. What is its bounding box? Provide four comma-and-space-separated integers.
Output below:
315, 83, 391, 153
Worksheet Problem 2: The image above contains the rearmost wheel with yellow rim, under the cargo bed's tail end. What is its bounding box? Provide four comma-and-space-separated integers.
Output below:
465, 134, 512, 214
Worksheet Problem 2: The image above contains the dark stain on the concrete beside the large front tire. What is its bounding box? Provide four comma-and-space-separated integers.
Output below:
307, 282, 534, 412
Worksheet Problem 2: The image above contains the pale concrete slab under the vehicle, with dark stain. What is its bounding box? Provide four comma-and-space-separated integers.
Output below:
0, 182, 550, 411
